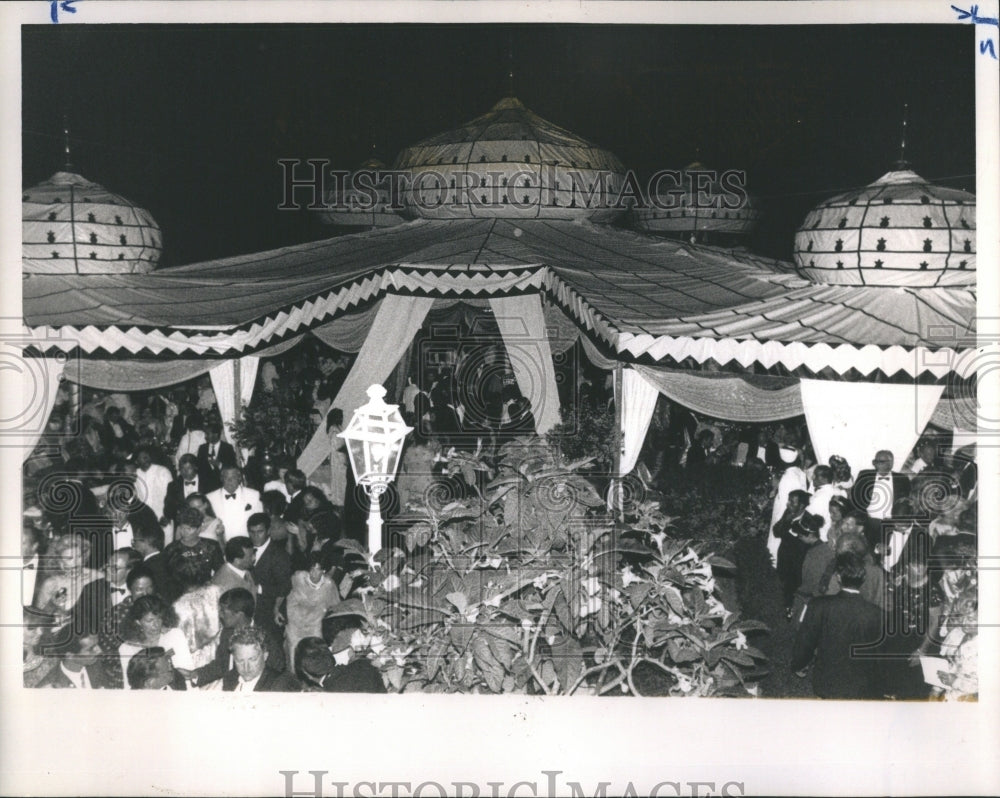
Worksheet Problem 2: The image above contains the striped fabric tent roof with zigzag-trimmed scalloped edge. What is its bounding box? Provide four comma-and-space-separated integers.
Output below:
23, 219, 975, 376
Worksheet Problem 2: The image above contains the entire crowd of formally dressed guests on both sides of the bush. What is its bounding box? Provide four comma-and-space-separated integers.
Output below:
22, 340, 978, 698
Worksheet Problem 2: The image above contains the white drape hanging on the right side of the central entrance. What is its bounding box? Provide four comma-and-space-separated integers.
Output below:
490, 294, 560, 435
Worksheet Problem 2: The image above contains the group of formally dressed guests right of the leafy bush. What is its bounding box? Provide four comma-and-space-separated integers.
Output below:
768, 439, 978, 700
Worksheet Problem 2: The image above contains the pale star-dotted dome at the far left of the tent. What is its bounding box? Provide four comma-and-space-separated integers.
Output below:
21, 172, 163, 274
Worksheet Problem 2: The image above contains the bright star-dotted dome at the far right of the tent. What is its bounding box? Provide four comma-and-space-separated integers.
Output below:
794, 169, 976, 286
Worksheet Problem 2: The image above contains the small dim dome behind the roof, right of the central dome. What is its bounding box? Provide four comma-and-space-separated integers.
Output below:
633, 163, 760, 244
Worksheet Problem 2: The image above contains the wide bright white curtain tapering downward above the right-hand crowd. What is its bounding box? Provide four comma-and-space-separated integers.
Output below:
801, 380, 944, 475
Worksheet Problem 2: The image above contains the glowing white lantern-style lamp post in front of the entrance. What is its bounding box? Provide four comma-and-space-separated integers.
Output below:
337, 385, 413, 554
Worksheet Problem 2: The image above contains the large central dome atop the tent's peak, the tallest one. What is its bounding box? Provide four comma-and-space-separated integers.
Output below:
395, 97, 625, 222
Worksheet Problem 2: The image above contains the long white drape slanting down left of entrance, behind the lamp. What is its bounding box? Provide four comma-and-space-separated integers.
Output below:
298, 294, 434, 476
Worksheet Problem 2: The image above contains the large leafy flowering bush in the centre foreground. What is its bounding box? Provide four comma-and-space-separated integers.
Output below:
334, 444, 765, 695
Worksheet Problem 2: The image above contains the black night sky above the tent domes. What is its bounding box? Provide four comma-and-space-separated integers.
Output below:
22, 24, 975, 265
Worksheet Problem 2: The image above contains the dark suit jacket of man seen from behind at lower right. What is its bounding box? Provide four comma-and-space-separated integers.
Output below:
791, 590, 883, 698
